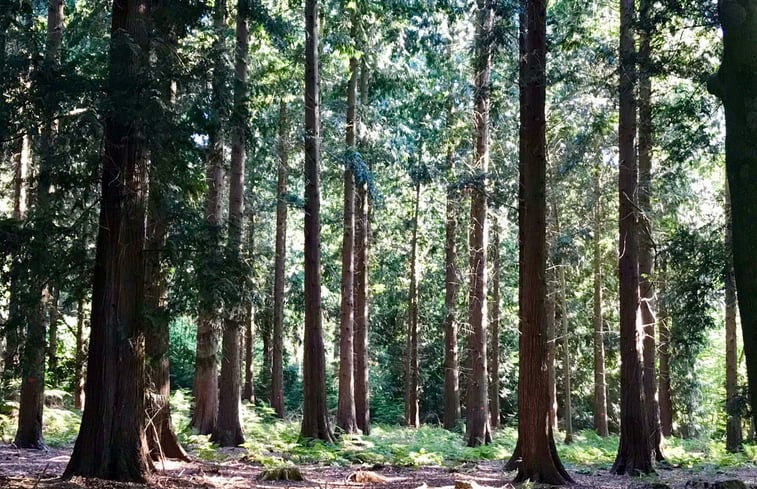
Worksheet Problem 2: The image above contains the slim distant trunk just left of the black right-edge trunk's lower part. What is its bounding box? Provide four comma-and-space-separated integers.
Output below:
725, 184, 743, 452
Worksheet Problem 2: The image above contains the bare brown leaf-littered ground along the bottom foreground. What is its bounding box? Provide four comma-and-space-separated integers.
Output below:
0, 445, 757, 489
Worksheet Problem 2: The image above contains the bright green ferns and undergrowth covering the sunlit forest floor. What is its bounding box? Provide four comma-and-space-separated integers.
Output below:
0, 391, 757, 473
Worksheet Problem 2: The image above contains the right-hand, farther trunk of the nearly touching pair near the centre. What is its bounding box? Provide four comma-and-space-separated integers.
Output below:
354, 58, 371, 435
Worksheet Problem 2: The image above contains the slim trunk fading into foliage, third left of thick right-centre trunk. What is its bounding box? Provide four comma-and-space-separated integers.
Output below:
444, 146, 460, 430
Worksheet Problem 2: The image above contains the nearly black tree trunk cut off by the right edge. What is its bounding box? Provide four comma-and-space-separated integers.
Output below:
709, 0, 757, 446
